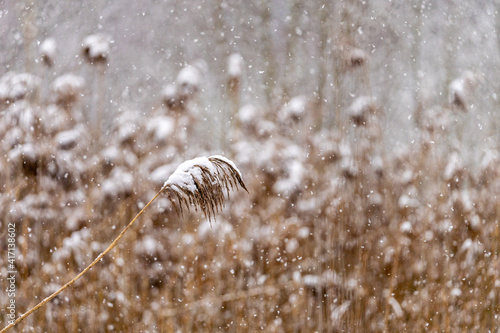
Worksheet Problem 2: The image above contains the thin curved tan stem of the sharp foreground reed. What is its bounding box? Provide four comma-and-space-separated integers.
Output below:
0, 188, 163, 333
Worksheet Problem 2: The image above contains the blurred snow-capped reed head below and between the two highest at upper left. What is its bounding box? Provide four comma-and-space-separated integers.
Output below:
52, 74, 85, 108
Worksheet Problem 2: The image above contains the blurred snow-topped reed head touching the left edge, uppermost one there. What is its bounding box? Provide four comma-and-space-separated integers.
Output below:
0, 72, 40, 104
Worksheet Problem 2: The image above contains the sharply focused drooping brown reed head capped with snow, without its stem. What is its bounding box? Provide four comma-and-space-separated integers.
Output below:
162, 155, 248, 220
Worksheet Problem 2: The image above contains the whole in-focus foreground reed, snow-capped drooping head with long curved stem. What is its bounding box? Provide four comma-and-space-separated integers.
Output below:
0, 155, 247, 333
